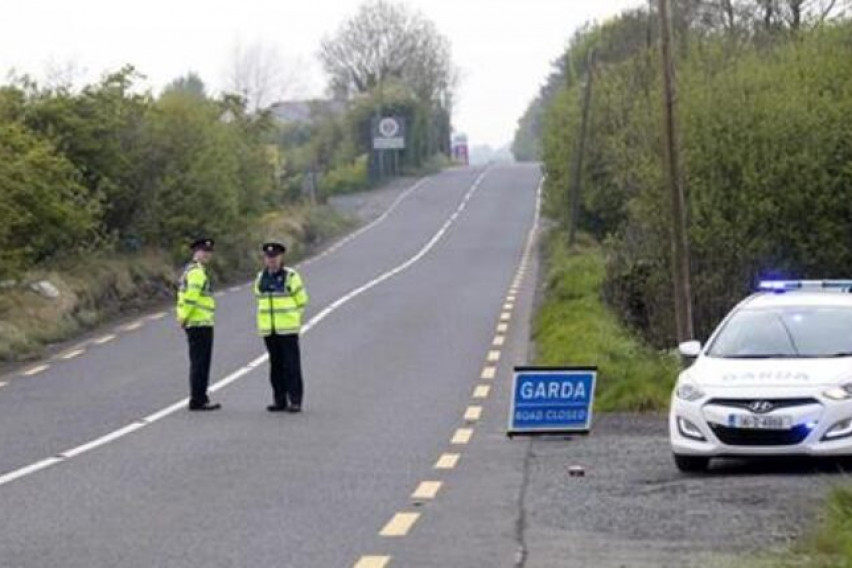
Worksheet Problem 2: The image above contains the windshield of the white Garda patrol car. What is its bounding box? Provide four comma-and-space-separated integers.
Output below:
708, 306, 852, 359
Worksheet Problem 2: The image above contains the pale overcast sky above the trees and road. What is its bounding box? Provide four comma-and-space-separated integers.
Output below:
0, 0, 638, 146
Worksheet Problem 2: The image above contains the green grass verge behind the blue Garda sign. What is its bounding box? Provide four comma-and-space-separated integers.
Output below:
533, 229, 679, 411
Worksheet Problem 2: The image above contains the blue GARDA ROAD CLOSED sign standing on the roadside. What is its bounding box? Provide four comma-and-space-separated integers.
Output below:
509, 367, 597, 436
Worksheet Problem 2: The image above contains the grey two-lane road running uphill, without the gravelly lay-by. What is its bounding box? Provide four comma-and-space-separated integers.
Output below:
0, 166, 540, 568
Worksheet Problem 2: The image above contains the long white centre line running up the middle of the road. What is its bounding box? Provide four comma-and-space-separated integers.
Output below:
0, 169, 489, 486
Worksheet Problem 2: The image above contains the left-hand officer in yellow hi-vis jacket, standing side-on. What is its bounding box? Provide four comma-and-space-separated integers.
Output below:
177, 239, 221, 410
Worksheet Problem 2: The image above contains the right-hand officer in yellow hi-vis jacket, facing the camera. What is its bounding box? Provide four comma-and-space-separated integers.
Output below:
254, 242, 308, 412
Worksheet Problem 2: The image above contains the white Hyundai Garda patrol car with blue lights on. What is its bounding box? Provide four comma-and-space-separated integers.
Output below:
669, 280, 852, 471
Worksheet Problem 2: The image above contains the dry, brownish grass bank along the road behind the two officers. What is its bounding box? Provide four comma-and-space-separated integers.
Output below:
0, 206, 351, 363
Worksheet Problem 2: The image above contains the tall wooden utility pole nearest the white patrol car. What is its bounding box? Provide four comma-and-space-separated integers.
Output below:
659, 0, 695, 342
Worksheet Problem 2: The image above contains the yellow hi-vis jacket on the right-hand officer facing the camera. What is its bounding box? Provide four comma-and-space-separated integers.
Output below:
254, 268, 308, 336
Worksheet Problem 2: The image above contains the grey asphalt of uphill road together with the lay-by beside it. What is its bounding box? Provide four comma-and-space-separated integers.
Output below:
0, 162, 846, 568
